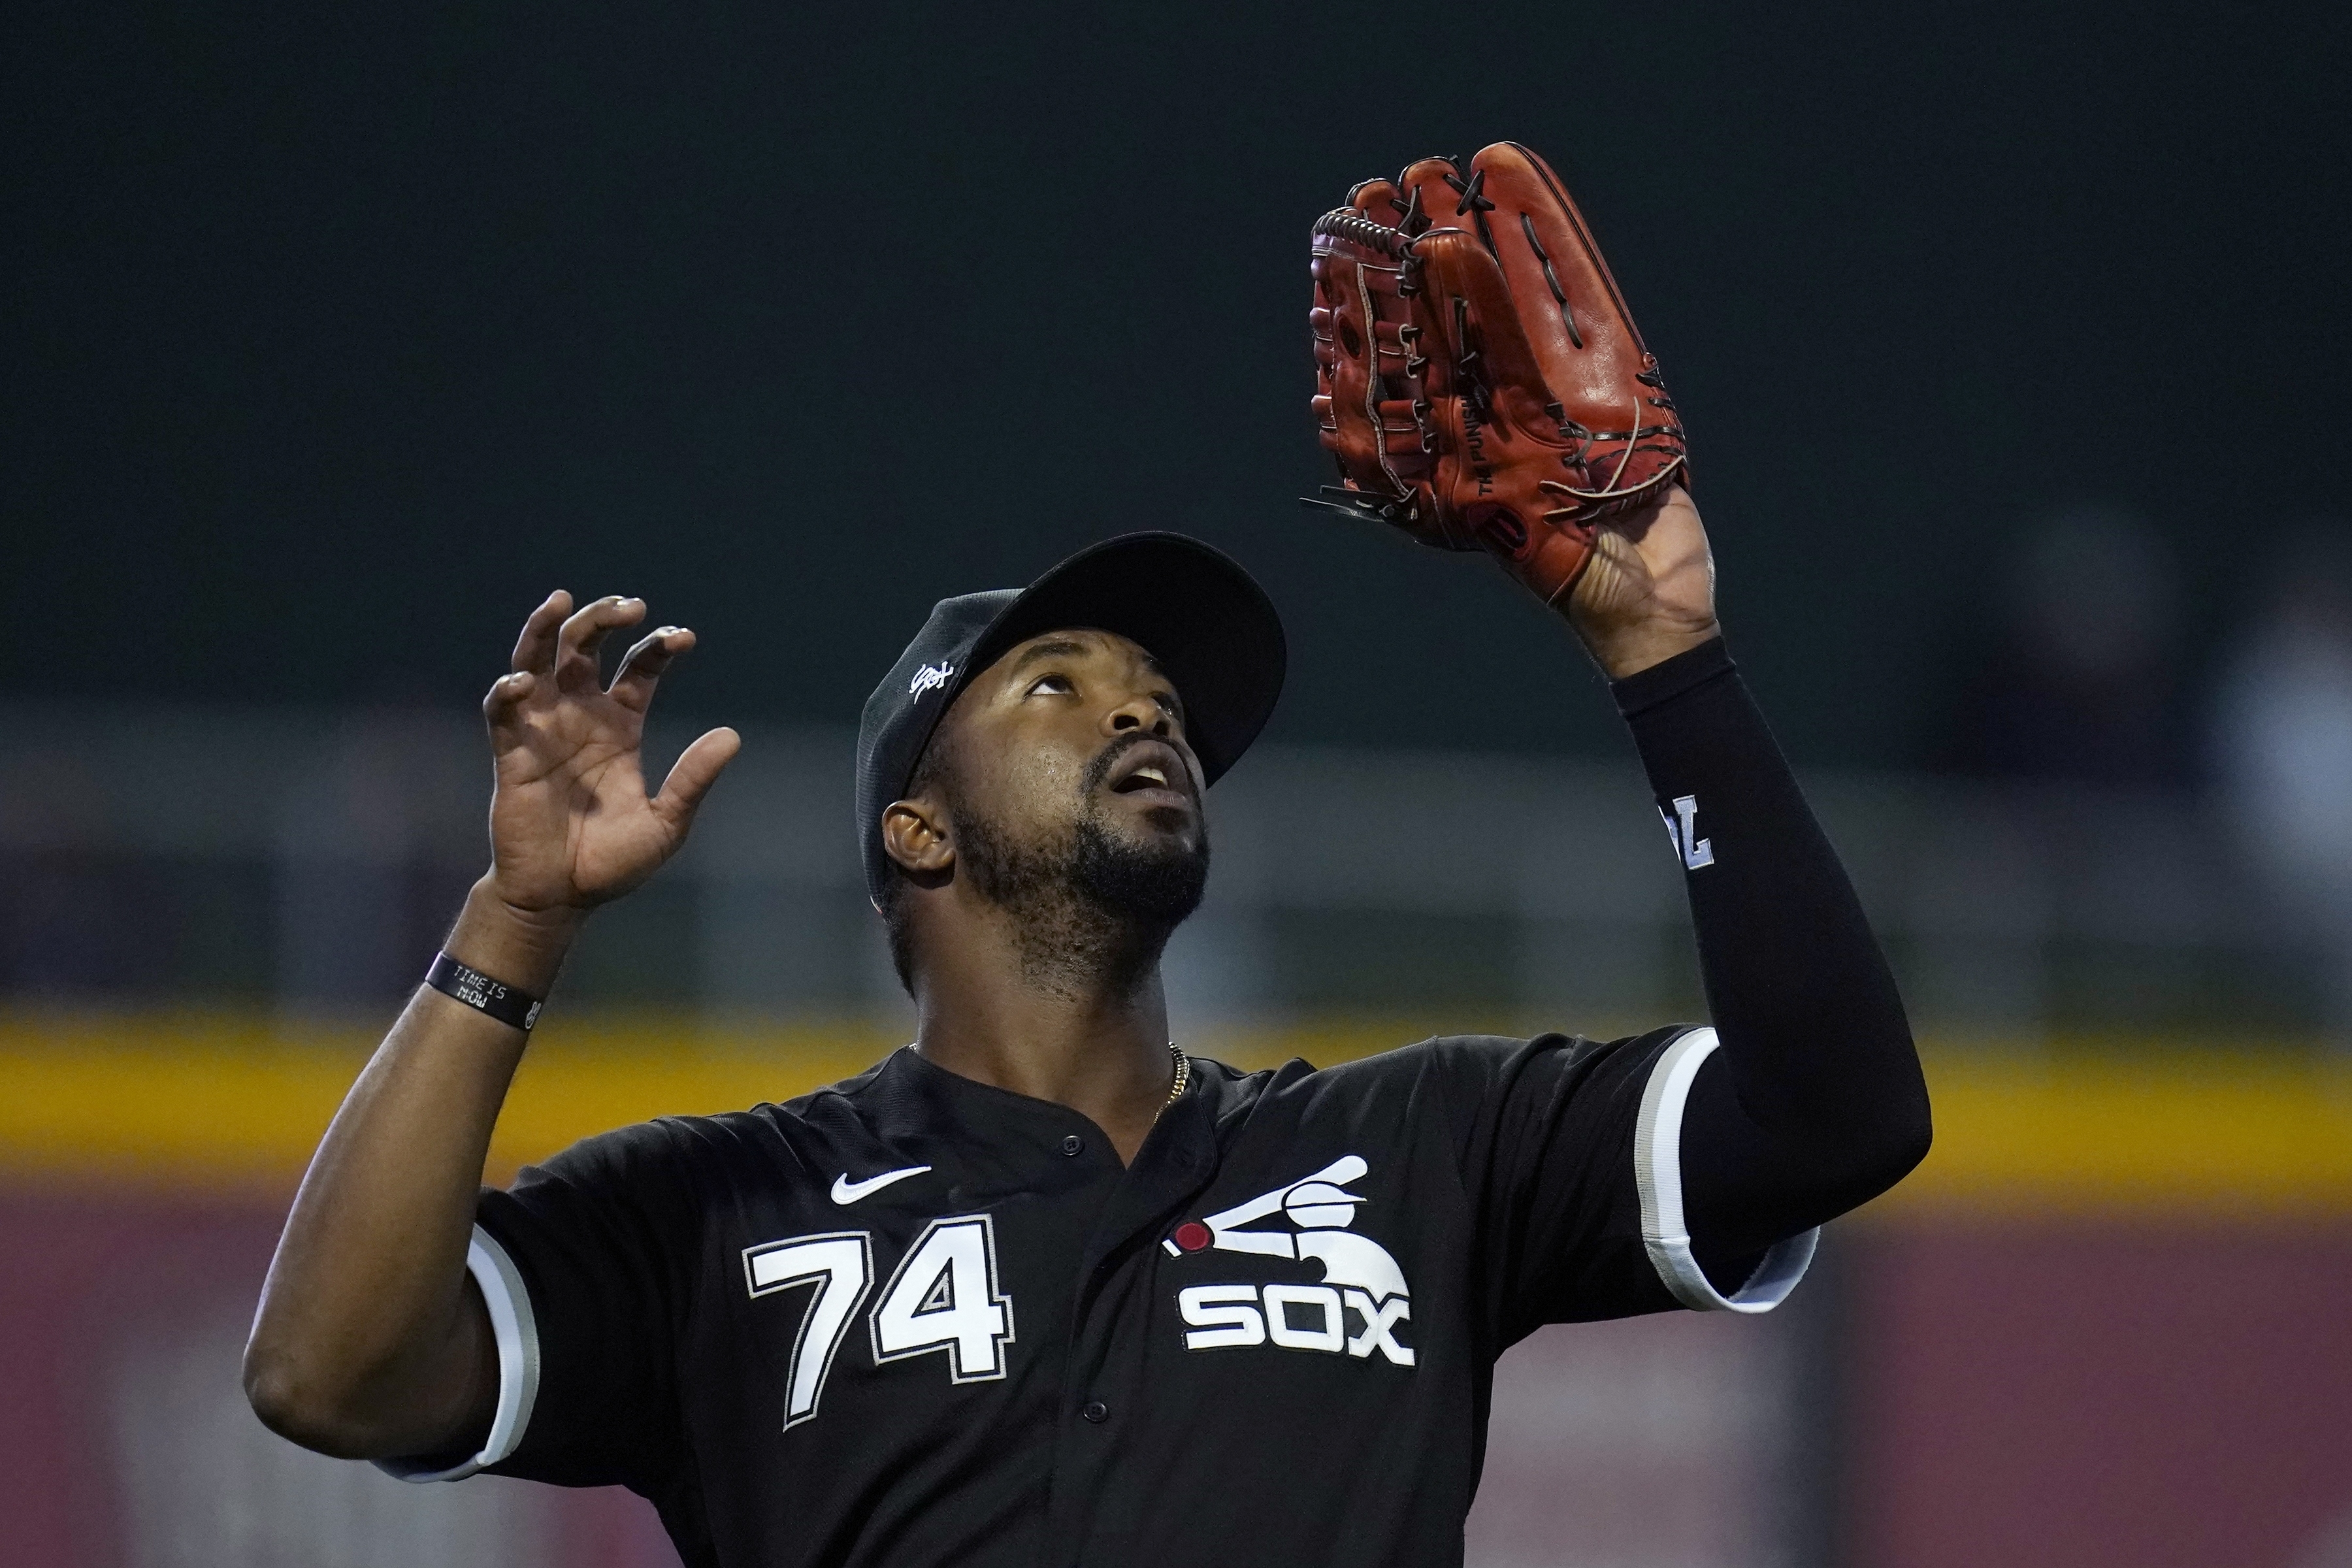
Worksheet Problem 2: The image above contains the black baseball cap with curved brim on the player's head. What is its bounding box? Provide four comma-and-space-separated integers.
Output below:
858, 534, 1289, 900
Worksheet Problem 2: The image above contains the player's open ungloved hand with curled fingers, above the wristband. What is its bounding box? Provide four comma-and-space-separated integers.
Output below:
482, 590, 741, 924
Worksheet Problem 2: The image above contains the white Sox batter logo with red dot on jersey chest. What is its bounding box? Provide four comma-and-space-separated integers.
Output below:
1162, 1154, 1414, 1366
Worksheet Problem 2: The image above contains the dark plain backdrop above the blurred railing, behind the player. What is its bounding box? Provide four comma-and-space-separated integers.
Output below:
0, 3, 2352, 766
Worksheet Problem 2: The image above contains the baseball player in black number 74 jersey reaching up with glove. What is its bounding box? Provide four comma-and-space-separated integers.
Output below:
247, 146, 1929, 1568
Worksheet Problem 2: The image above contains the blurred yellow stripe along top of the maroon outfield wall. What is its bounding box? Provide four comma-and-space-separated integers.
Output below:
0, 1015, 2352, 1215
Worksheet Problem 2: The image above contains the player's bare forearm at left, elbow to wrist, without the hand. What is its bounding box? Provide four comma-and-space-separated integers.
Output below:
244, 889, 569, 1458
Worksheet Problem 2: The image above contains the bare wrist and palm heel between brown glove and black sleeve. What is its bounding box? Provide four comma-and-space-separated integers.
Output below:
1567, 484, 1722, 679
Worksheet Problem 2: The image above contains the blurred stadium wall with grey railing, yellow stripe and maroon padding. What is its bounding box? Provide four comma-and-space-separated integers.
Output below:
0, 708, 2352, 1568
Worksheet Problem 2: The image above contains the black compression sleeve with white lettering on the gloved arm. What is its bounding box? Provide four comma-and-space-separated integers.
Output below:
1611, 637, 1929, 1274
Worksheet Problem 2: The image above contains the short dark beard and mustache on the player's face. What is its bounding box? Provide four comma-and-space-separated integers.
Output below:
955, 743, 1209, 990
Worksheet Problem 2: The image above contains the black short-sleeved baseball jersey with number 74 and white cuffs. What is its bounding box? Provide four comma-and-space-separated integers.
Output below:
393, 1030, 1811, 1568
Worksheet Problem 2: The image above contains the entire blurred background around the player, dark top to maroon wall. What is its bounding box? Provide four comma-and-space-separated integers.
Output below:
0, 0, 2352, 1568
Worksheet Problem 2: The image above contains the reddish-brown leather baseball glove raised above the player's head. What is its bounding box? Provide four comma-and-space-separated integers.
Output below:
1308, 141, 1689, 604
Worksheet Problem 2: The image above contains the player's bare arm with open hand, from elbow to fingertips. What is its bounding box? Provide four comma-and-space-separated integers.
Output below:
244, 593, 743, 1458
